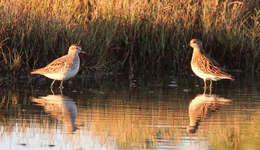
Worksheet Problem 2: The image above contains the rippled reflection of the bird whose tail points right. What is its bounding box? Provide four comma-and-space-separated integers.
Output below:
186, 94, 232, 133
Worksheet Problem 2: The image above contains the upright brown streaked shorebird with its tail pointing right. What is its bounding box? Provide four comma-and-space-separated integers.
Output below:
190, 39, 234, 92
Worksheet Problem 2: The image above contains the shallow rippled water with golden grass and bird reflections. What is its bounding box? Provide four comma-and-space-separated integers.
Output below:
0, 76, 260, 150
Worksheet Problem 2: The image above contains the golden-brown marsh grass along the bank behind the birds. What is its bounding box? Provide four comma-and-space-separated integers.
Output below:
0, 0, 260, 75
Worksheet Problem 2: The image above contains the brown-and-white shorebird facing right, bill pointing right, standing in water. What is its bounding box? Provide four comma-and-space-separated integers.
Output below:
31, 44, 86, 89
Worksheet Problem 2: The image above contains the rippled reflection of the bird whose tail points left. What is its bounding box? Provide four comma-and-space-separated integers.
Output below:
32, 95, 78, 132
